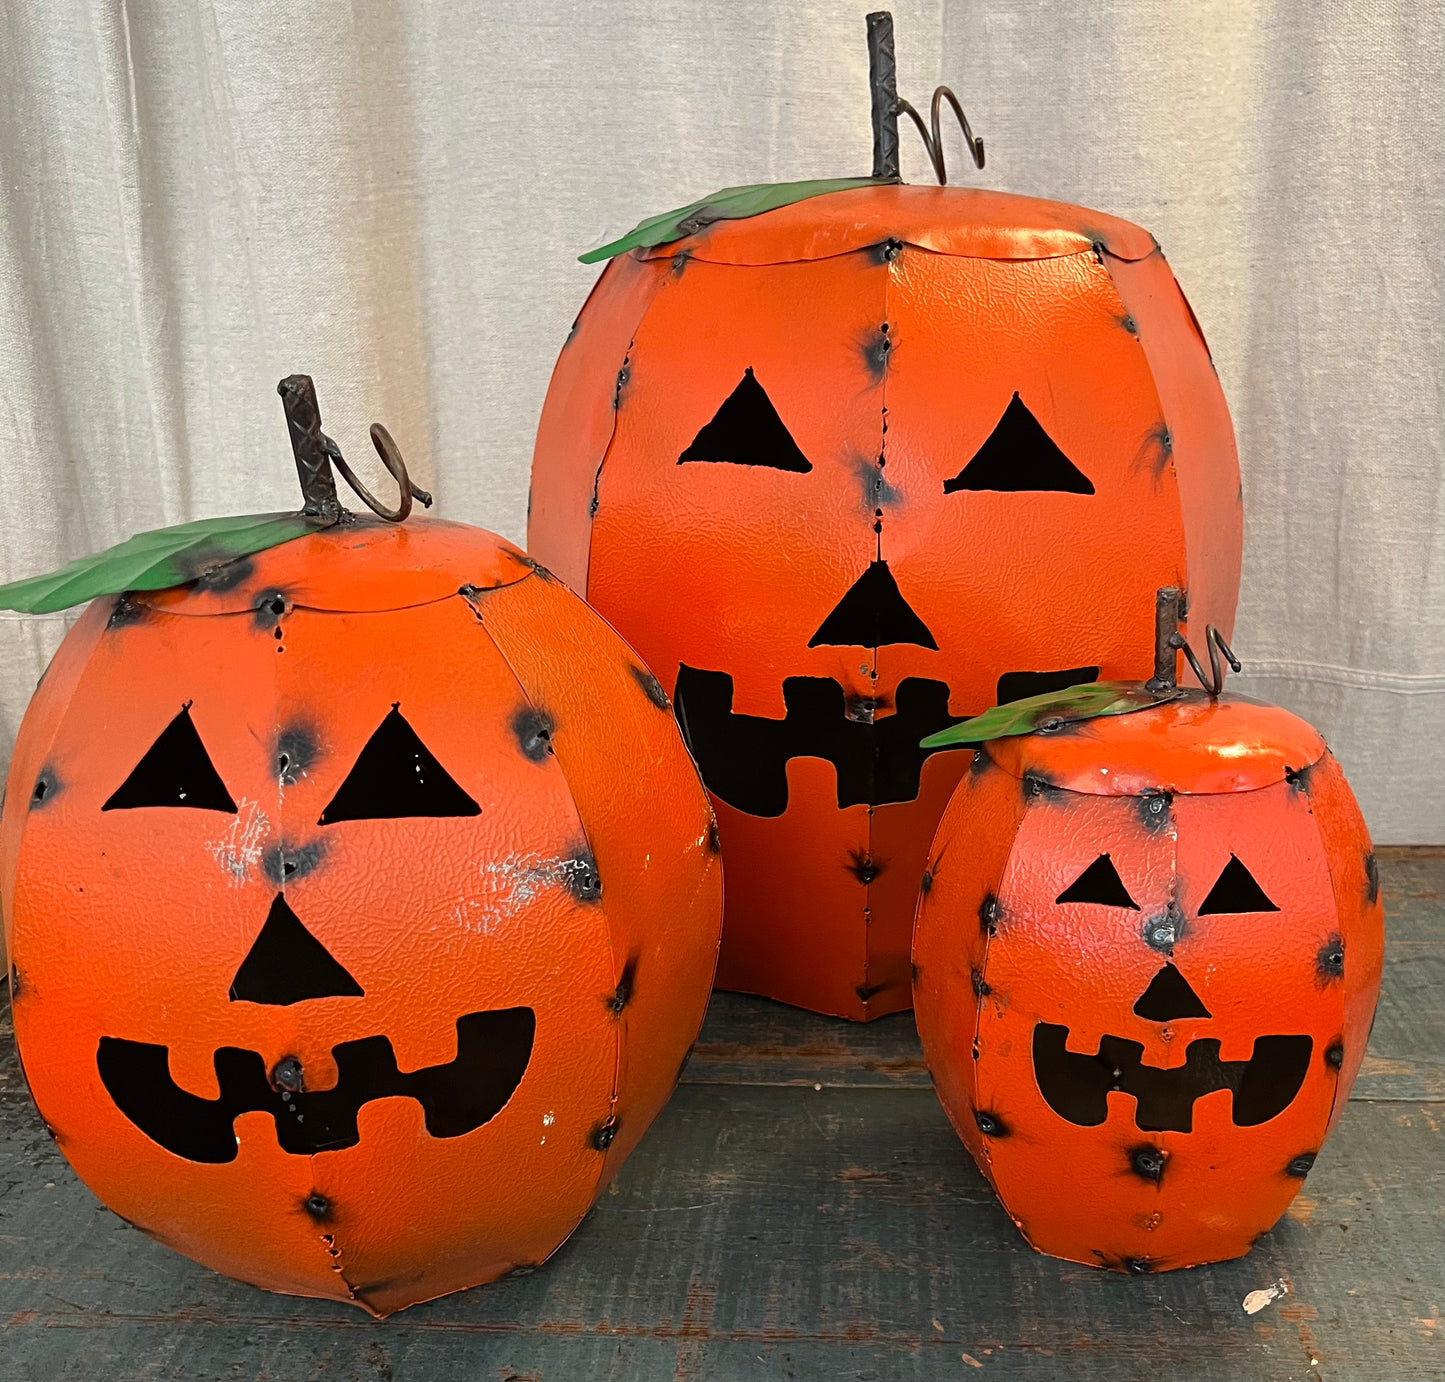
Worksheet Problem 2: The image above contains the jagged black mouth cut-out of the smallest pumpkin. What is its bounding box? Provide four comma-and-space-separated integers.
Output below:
1033, 1022, 1314, 1132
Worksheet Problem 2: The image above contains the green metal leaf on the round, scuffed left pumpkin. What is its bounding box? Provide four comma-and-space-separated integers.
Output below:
0, 513, 331, 614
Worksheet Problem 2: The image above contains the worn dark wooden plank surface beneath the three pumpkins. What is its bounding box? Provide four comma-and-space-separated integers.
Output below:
0, 851, 1445, 1382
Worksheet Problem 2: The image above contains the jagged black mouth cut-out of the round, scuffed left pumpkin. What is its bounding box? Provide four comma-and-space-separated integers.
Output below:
95, 1008, 536, 1168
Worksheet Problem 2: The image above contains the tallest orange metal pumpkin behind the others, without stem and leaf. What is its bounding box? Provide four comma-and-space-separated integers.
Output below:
529, 186, 1241, 1019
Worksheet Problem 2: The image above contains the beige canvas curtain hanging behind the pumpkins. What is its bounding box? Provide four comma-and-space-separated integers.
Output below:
0, 0, 1445, 843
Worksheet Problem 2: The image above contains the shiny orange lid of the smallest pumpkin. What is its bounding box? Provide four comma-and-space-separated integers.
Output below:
984, 691, 1327, 797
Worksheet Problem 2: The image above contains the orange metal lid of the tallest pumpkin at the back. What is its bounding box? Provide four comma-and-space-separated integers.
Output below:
639, 184, 1159, 265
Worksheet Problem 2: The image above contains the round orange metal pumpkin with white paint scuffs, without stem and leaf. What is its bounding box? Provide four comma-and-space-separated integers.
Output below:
0, 520, 721, 1314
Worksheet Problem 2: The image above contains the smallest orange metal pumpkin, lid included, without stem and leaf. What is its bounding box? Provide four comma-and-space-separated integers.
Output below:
913, 695, 1383, 1271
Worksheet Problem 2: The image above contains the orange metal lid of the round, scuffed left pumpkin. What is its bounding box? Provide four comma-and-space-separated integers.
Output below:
129, 518, 533, 614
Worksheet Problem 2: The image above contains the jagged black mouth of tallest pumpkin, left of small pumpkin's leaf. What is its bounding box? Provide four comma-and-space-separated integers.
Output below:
672, 664, 959, 815
